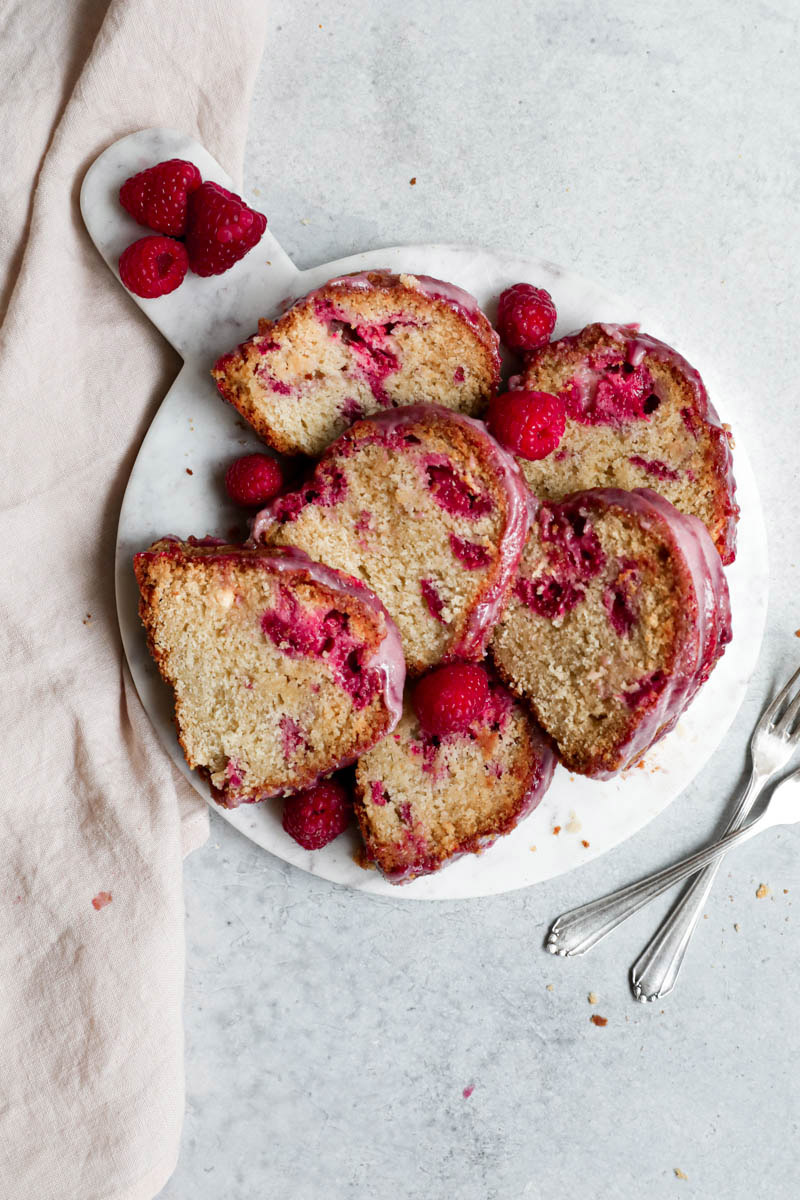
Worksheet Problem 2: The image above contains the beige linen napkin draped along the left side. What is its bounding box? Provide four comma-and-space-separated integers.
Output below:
0, 0, 266, 1200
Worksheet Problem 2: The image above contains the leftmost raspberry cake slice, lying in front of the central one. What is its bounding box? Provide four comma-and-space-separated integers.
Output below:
134, 538, 405, 808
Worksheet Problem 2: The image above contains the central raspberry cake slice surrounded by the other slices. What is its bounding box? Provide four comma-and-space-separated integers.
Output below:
252, 404, 529, 672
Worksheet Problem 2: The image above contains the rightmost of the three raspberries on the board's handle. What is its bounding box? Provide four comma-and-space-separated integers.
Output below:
186, 184, 266, 275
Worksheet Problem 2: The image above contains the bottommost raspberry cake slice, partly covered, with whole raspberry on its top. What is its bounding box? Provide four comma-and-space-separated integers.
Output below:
355, 680, 555, 883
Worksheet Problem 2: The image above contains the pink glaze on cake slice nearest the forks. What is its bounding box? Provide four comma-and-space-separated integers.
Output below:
537, 487, 732, 779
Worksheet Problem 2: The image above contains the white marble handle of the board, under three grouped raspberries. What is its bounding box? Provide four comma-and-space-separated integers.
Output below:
80, 130, 300, 366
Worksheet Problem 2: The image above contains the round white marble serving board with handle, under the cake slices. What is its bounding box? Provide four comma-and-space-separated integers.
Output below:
80, 130, 768, 900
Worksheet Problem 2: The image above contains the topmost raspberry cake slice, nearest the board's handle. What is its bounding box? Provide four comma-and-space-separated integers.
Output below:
212, 271, 500, 455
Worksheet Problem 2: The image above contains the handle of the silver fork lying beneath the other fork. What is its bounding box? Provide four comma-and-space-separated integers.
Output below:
631, 767, 768, 1002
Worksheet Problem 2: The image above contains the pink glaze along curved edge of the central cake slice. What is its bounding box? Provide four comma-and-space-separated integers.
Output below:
249, 404, 533, 659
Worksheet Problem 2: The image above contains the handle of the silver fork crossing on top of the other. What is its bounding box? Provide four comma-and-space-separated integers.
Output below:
547, 811, 774, 955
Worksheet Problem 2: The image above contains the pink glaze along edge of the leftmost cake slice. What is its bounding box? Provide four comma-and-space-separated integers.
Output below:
134, 535, 405, 808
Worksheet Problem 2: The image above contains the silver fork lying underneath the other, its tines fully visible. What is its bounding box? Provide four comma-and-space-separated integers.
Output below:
631, 671, 800, 1001
